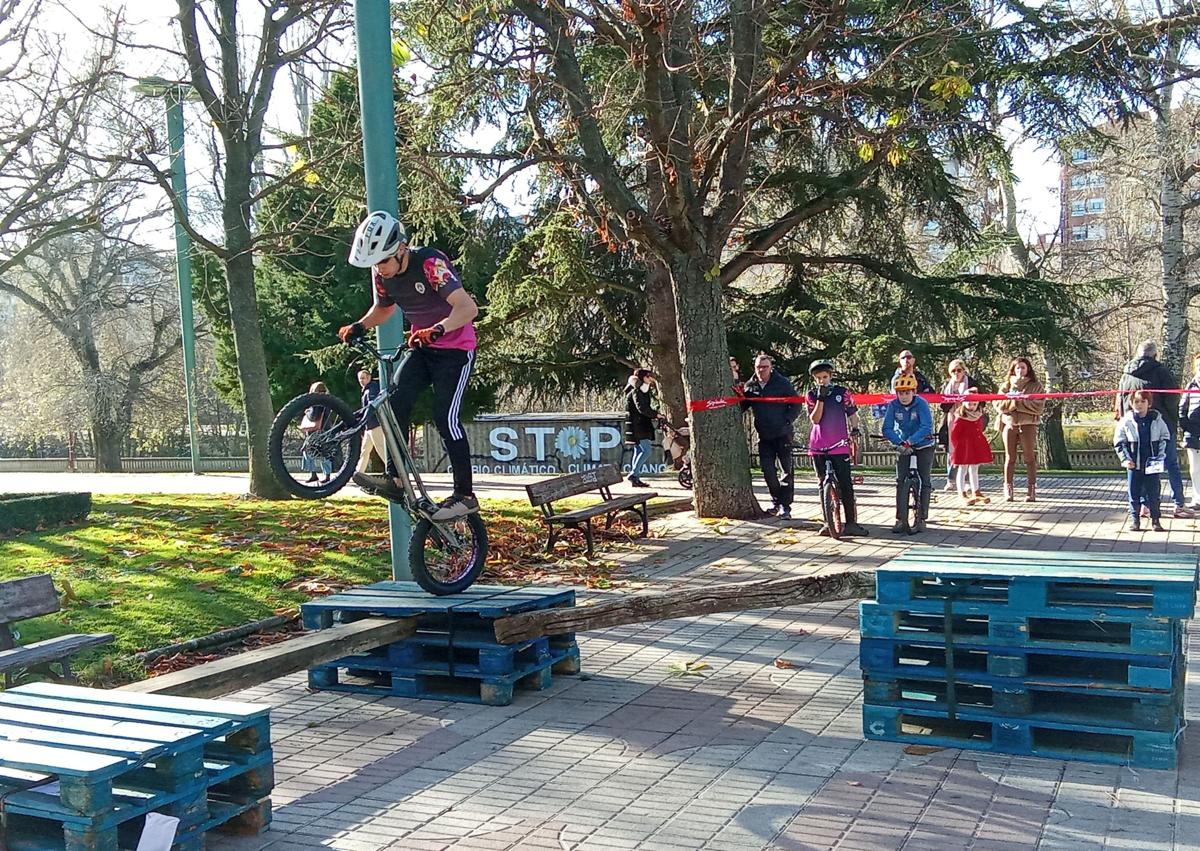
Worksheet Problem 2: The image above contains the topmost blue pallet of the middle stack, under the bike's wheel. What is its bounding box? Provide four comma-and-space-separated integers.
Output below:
300, 581, 575, 633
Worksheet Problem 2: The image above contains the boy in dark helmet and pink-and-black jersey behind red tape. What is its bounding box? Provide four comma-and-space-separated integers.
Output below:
806, 359, 870, 537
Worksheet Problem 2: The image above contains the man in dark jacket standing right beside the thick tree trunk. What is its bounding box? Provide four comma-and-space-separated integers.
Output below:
742, 354, 800, 520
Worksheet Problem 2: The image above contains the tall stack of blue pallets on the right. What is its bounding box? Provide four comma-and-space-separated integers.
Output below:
859, 547, 1196, 768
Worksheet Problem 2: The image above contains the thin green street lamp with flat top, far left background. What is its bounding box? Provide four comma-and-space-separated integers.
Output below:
133, 77, 200, 475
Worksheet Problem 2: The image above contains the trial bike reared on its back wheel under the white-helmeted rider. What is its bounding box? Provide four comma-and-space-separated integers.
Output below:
269, 337, 487, 595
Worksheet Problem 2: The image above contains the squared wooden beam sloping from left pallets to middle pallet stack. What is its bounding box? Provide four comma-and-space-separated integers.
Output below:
122, 618, 416, 697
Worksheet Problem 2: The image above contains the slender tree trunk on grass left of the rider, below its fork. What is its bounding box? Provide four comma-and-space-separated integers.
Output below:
222, 138, 288, 499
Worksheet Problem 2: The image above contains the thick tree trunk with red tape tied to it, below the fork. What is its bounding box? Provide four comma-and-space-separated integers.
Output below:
671, 252, 762, 517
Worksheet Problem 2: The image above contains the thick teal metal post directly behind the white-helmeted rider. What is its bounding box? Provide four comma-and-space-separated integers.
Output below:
354, 0, 413, 580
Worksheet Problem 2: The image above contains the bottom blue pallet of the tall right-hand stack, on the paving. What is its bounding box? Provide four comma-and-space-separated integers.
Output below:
863, 703, 1182, 769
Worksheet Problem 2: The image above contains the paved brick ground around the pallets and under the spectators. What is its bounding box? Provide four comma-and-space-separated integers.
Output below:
201, 477, 1200, 851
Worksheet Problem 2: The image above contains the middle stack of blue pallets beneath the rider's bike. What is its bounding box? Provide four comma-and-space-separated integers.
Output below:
301, 582, 580, 706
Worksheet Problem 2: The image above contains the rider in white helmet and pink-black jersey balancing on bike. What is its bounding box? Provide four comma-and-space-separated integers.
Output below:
337, 210, 479, 520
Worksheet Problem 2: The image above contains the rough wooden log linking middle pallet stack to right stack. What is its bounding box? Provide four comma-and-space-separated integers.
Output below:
496, 570, 875, 645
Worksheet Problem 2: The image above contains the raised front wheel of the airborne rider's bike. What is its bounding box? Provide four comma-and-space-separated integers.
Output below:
268, 392, 362, 499
